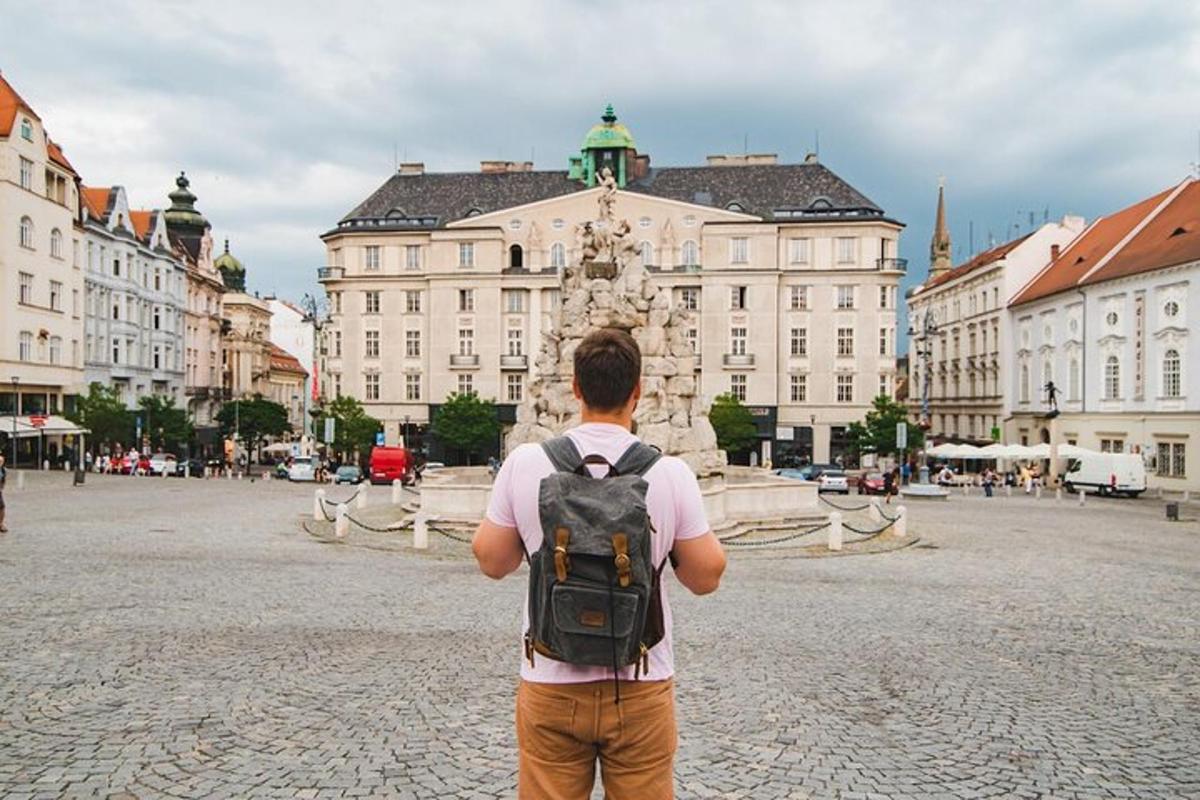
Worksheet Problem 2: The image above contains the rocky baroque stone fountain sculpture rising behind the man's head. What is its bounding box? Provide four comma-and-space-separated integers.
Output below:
508, 168, 726, 477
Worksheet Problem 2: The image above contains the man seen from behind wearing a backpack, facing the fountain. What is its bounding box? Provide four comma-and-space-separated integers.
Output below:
473, 329, 725, 800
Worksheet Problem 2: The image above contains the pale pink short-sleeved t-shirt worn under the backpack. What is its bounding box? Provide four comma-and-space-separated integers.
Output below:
487, 422, 708, 684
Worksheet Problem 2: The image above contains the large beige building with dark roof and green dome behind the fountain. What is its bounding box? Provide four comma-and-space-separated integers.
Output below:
318, 108, 905, 462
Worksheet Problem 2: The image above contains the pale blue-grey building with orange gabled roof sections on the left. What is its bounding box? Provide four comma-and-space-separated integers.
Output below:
83, 186, 187, 408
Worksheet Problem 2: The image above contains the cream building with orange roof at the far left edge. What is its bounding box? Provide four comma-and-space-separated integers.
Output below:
0, 76, 84, 448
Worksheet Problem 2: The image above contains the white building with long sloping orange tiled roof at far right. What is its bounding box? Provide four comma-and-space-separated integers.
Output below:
1006, 179, 1200, 492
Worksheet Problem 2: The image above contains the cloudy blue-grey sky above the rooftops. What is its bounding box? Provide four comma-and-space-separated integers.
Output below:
0, 0, 1200, 326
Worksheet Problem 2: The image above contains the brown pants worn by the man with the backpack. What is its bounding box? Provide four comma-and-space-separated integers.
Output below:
517, 680, 676, 800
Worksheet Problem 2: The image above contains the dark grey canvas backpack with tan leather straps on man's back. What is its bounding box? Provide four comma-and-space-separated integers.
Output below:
526, 437, 666, 691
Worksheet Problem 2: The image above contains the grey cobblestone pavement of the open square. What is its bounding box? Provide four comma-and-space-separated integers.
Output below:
0, 475, 1200, 800
